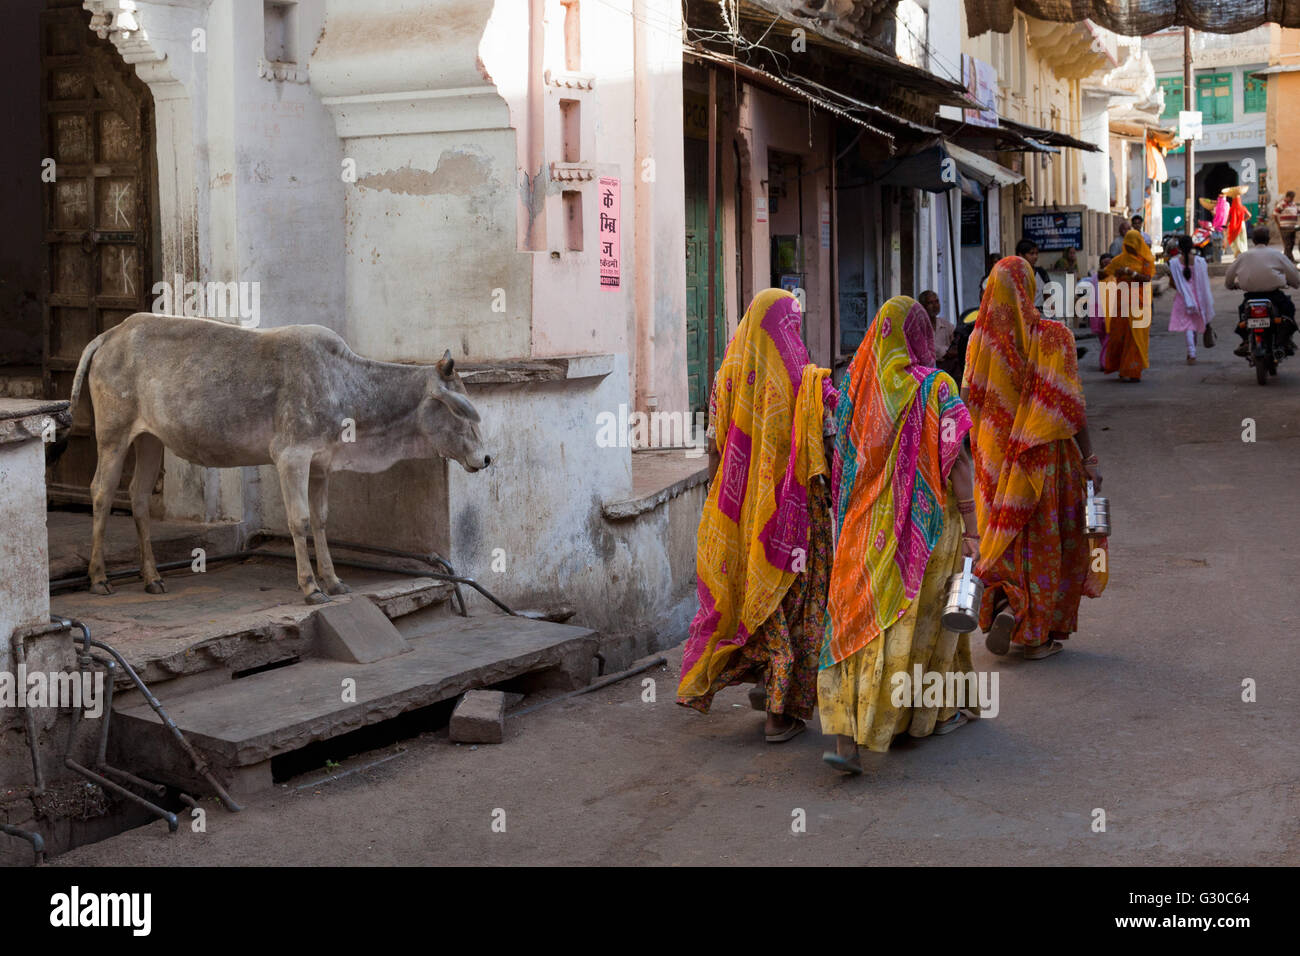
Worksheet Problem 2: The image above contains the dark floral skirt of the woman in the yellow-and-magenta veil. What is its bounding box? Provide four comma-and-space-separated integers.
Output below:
677, 477, 832, 721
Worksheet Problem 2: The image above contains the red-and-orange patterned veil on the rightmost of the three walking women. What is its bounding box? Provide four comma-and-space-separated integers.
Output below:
962, 257, 1086, 572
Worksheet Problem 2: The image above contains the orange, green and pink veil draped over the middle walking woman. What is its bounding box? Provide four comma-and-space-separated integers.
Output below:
820, 295, 971, 669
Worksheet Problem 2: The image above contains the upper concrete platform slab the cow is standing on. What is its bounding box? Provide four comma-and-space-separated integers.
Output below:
51, 558, 451, 684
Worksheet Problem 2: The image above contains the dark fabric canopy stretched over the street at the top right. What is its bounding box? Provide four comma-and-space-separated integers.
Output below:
966, 0, 1300, 36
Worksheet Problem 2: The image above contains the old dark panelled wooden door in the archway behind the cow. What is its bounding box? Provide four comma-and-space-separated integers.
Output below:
40, 0, 153, 503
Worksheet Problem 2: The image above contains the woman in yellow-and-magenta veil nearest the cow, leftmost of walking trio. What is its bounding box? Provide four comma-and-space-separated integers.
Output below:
677, 289, 837, 743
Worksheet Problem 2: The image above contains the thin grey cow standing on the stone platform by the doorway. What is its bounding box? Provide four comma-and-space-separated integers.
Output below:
72, 312, 491, 604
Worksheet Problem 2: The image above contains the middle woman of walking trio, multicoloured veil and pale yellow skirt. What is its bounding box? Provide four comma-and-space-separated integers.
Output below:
818, 295, 979, 774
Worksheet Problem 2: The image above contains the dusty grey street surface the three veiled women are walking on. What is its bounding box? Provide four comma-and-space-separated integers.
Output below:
56, 282, 1300, 865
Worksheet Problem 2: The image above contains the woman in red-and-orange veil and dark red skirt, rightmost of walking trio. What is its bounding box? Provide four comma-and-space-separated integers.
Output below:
962, 261, 1107, 661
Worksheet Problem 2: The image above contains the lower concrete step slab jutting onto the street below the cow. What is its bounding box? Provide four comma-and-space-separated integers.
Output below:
113, 614, 597, 790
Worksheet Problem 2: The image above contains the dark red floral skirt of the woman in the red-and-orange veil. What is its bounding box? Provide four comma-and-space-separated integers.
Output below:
980, 438, 1109, 648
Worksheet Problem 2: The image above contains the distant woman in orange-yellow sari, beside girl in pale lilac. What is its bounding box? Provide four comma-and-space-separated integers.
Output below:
1097, 229, 1156, 382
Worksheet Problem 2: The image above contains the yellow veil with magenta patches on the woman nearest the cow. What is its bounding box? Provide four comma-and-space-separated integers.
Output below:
677, 289, 839, 697
